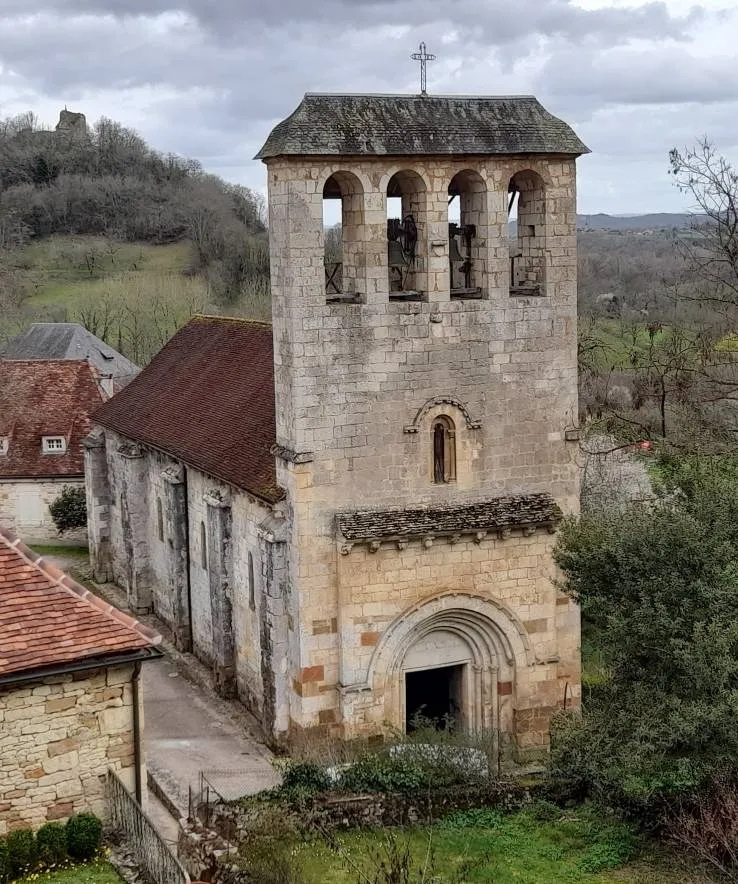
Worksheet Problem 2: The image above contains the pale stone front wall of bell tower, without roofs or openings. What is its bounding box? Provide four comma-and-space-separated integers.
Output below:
266, 109, 580, 759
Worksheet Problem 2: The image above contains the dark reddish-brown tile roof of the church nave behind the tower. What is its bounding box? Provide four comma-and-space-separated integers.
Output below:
92, 316, 282, 503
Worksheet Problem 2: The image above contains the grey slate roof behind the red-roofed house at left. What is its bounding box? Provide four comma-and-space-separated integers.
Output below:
2, 322, 139, 388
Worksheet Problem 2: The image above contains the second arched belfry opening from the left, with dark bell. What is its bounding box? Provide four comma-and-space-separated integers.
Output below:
387, 170, 428, 301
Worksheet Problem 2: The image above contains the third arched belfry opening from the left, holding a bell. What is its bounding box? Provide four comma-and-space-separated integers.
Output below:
448, 169, 489, 300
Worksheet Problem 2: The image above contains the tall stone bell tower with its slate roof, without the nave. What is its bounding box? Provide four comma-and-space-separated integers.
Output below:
258, 94, 587, 759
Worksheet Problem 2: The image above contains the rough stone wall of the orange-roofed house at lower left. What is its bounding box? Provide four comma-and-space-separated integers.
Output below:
0, 665, 139, 835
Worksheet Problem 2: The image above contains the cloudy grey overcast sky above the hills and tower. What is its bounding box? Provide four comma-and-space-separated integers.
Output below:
0, 0, 738, 213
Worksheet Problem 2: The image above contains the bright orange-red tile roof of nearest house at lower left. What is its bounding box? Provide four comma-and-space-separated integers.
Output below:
0, 528, 161, 679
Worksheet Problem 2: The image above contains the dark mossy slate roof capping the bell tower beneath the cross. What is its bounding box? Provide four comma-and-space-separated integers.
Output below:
256, 92, 589, 160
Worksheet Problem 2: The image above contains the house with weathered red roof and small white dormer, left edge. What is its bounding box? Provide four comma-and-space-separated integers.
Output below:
0, 359, 112, 543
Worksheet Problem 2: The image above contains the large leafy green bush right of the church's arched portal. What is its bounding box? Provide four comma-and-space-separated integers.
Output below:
552, 461, 738, 828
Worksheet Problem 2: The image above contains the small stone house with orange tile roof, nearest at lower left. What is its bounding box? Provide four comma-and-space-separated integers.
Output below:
0, 528, 161, 835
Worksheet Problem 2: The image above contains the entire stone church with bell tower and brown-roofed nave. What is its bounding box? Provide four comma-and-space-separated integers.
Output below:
85, 94, 588, 762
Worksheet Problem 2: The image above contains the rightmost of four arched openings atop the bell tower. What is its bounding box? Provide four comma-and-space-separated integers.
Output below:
508, 169, 546, 297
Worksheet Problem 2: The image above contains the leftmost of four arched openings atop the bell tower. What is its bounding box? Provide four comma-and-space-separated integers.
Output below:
323, 171, 366, 303
